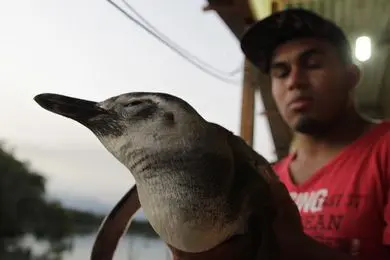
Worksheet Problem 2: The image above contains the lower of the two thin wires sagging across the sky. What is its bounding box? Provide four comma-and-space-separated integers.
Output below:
107, 0, 242, 84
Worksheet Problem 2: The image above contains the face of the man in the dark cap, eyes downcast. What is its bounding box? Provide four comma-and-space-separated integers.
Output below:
270, 39, 354, 135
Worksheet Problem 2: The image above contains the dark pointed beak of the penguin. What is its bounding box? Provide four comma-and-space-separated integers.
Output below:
34, 93, 108, 125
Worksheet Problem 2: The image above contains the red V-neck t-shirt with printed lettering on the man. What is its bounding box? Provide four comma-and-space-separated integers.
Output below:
274, 122, 390, 260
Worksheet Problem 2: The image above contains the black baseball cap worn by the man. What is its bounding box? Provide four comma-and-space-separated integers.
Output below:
241, 8, 353, 73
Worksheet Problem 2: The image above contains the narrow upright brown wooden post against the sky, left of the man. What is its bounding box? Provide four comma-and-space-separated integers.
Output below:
240, 59, 255, 146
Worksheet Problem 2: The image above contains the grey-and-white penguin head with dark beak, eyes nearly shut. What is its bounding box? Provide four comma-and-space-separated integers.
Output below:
34, 92, 205, 163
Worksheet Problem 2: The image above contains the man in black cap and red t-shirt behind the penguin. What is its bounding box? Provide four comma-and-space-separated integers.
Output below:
241, 9, 390, 260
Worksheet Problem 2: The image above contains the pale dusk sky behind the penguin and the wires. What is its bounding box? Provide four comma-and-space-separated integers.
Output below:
0, 0, 275, 215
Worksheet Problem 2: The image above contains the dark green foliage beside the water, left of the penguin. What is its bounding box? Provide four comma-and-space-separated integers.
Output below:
0, 144, 102, 260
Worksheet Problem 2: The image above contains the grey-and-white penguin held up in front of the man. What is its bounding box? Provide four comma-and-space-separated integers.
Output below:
34, 92, 279, 260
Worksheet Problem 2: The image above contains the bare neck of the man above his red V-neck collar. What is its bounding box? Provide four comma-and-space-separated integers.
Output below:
295, 111, 373, 157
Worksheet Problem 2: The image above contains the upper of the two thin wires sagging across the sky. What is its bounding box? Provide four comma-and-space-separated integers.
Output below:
122, 0, 242, 76
